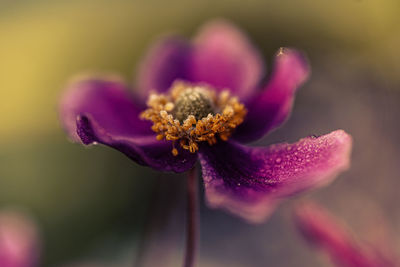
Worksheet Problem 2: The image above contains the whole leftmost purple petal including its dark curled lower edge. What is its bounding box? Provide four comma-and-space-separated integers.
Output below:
60, 79, 197, 172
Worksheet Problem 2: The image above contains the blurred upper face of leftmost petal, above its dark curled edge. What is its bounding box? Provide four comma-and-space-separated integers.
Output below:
60, 78, 152, 141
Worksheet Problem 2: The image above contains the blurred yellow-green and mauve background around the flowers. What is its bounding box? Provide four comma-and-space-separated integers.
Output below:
0, 0, 400, 267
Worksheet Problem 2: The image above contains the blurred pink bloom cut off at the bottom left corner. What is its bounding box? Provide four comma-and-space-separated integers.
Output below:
0, 211, 39, 267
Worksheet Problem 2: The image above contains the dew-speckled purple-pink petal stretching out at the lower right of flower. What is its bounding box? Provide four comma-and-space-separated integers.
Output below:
200, 130, 352, 223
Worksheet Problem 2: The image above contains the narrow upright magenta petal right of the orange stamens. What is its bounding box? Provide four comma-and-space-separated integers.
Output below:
234, 49, 310, 142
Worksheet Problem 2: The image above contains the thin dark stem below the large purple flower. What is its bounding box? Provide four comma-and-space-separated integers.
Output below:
183, 167, 199, 267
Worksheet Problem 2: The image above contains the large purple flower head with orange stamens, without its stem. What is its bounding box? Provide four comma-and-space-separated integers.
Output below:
60, 21, 352, 222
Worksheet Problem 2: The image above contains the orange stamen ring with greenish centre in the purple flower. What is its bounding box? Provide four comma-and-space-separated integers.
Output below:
140, 81, 247, 156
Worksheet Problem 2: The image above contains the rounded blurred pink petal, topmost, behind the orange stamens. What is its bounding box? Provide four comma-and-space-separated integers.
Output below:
190, 20, 264, 100
